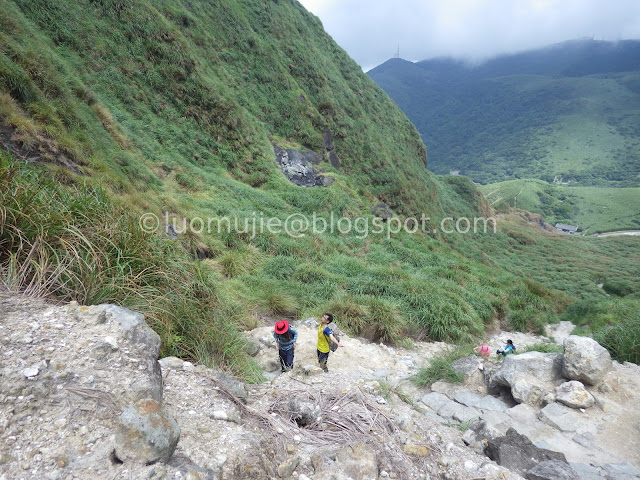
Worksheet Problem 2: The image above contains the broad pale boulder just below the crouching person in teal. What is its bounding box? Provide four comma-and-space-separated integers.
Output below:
487, 352, 562, 406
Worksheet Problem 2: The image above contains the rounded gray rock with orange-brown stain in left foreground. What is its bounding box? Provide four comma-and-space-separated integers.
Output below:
115, 398, 180, 465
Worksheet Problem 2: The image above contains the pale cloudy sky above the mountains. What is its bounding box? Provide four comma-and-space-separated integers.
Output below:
299, 0, 640, 71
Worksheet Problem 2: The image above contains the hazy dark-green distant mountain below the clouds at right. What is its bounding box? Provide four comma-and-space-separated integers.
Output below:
368, 40, 640, 186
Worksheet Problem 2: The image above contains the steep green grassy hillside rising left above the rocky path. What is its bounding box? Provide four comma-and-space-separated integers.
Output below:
0, 0, 636, 380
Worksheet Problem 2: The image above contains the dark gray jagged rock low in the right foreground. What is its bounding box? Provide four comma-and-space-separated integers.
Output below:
485, 428, 567, 475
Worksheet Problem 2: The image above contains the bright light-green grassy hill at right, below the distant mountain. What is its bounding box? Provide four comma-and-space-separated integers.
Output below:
480, 180, 640, 235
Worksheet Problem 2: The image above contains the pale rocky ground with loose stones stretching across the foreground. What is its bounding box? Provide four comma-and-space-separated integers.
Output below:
0, 293, 640, 480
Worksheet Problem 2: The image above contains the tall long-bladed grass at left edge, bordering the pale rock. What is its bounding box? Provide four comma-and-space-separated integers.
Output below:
0, 155, 260, 381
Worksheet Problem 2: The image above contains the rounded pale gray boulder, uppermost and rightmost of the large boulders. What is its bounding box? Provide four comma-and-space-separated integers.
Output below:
562, 335, 613, 385
